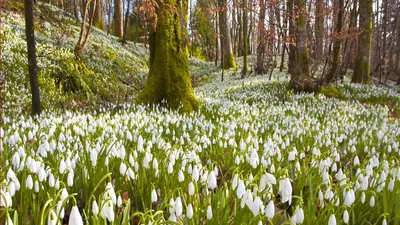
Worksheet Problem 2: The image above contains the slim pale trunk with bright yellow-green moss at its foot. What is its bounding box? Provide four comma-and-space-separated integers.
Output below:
218, 0, 236, 69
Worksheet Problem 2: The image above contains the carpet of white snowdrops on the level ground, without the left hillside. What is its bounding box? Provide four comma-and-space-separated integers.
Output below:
1, 72, 400, 225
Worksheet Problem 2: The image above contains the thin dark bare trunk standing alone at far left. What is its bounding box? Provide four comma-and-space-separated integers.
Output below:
25, 0, 41, 115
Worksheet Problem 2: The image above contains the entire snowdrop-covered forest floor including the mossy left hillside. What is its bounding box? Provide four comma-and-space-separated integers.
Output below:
0, 1, 400, 225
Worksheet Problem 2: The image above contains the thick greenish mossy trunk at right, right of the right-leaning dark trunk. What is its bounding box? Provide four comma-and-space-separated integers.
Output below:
352, 0, 372, 84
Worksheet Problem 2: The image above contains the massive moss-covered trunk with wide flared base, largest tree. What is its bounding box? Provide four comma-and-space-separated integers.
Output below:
137, 0, 199, 112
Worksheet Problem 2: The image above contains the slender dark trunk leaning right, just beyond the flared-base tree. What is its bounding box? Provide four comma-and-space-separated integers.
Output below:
325, 0, 344, 83
